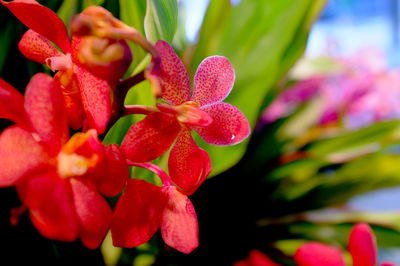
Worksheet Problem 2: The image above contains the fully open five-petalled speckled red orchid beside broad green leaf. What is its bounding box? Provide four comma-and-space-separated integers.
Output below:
121, 41, 250, 194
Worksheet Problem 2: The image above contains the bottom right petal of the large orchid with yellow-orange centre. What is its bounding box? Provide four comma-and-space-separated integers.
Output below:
70, 178, 112, 249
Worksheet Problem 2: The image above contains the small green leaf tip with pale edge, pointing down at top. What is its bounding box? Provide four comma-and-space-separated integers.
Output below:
144, 0, 178, 43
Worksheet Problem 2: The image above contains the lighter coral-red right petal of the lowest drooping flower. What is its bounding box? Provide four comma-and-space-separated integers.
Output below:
161, 186, 199, 254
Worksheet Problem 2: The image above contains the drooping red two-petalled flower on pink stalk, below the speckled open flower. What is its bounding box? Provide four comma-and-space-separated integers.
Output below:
111, 163, 199, 253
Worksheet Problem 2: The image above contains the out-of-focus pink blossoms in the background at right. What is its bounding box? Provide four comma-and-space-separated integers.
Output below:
262, 49, 400, 129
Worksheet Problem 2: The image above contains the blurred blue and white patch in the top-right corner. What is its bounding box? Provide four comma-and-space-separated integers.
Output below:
306, 0, 400, 67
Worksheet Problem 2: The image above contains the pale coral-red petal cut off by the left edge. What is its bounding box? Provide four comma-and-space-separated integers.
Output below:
0, 126, 49, 187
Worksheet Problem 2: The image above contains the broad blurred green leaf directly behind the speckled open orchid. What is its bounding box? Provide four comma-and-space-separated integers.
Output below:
191, 0, 325, 175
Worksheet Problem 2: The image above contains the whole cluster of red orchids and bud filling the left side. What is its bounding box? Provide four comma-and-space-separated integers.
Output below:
0, 0, 250, 253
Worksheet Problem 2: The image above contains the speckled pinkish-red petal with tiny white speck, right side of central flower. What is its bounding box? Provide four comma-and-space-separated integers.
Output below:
193, 103, 250, 146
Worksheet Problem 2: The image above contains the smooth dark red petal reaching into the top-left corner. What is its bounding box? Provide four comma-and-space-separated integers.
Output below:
0, 0, 71, 53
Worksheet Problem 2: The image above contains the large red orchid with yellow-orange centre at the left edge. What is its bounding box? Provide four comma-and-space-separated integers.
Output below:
0, 73, 129, 248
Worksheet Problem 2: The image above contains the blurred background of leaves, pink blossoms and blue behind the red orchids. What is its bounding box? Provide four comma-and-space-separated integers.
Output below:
0, 0, 400, 266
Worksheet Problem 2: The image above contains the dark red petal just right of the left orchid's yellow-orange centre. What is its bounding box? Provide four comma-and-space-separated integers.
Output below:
90, 144, 129, 197
